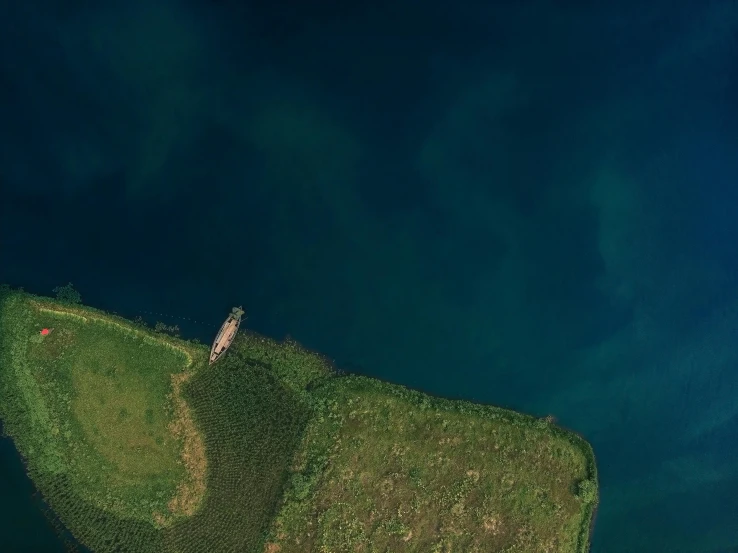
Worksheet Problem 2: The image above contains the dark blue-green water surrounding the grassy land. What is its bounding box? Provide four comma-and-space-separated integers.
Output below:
0, 0, 738, 553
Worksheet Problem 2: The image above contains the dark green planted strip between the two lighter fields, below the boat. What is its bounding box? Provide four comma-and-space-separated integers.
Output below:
161, 338, 309, 553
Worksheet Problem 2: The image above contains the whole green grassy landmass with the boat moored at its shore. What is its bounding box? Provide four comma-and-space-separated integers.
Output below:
0, 286, 598, 553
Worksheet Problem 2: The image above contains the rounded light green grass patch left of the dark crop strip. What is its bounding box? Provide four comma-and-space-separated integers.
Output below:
10, 302, 193, 522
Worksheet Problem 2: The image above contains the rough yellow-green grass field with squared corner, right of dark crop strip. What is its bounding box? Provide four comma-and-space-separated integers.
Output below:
270, 377, 594, 553
